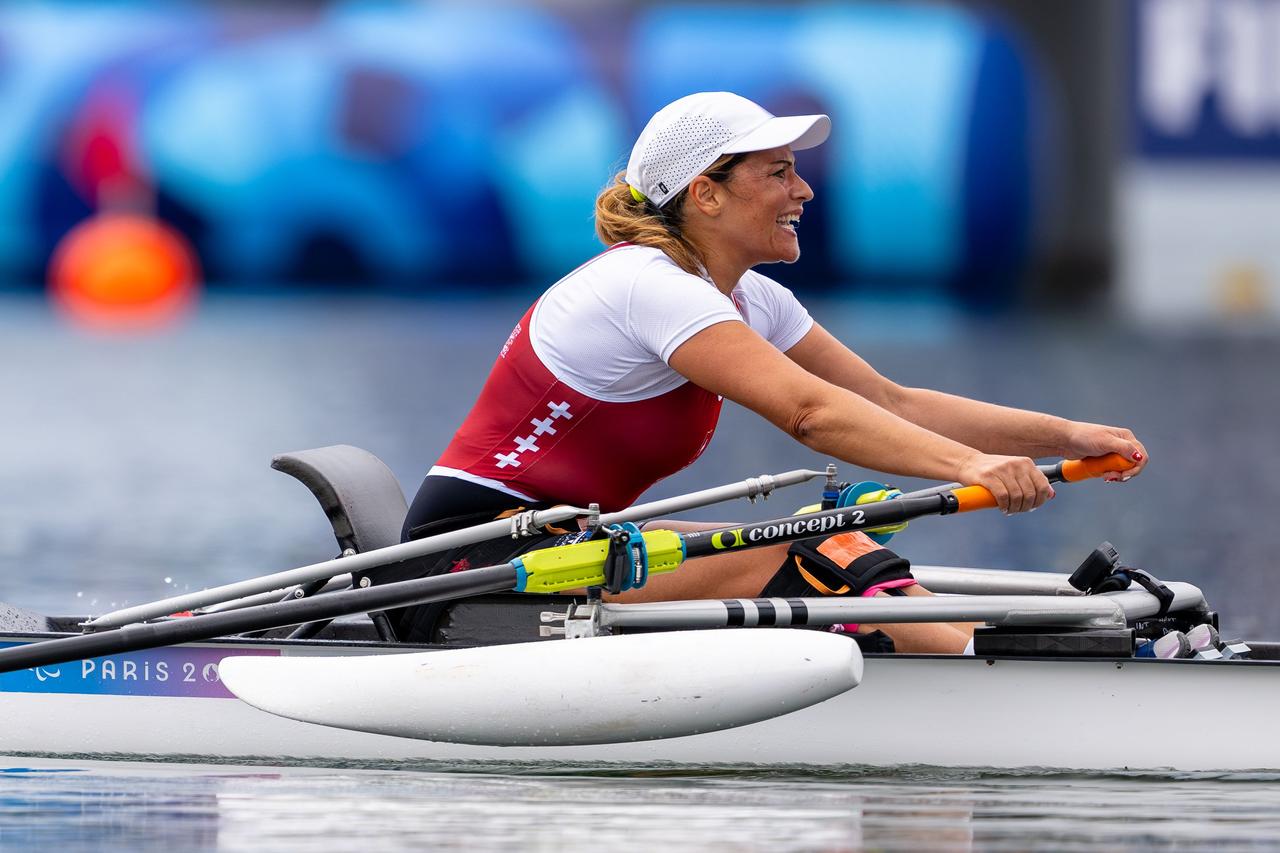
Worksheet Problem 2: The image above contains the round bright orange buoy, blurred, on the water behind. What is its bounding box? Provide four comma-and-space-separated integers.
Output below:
49, 213, 200, 330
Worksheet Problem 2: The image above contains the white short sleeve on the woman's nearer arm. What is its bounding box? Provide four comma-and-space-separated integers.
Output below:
627, 263, 742, 362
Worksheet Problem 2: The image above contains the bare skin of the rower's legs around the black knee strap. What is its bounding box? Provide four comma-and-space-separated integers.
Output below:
605, 521, 973, 654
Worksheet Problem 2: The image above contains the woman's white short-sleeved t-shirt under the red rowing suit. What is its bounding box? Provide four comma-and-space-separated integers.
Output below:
529, 245, 813, 402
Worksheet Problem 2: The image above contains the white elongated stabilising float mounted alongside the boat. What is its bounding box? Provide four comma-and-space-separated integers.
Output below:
219, 630, 863, 747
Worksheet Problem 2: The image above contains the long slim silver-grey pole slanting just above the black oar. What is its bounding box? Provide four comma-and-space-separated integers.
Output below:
84, 470, 823, 630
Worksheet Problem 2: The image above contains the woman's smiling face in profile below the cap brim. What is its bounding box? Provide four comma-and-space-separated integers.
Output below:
708, 146, 813, 272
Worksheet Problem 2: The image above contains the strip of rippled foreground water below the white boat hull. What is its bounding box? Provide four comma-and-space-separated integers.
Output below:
0, 757, 1280, 850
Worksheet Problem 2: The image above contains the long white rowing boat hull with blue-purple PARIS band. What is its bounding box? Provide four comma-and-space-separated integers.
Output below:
0, 637, 1280, 771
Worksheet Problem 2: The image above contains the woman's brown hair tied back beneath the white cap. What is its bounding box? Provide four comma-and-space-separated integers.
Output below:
595, 154, 746, 275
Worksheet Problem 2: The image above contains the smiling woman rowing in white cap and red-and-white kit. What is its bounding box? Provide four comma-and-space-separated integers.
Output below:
379, 92, 1147, 652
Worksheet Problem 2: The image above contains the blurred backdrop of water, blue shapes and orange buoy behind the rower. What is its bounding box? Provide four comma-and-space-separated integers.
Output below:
0, 0, 1280, 635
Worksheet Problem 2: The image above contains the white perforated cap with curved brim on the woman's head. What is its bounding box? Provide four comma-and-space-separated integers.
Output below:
626, 92, 831, 207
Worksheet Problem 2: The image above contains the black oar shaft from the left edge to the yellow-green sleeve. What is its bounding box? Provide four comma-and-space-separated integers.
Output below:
0, 564, 516, 672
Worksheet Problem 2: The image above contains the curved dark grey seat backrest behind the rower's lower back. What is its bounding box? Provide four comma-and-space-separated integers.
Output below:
271, 444, 408, 552
